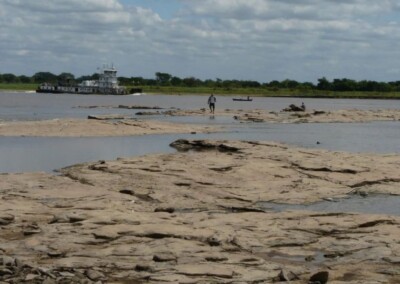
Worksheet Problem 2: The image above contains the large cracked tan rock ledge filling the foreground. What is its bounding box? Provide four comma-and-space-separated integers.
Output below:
0, 140, 400, 284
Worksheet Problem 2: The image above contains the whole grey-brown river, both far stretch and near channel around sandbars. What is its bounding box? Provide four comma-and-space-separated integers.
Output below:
0, 92, 400, 173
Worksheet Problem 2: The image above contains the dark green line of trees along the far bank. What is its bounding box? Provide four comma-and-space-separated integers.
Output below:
0, 72, 400, 92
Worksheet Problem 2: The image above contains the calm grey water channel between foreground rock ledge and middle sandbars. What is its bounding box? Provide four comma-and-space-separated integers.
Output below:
0, 120, 400, 172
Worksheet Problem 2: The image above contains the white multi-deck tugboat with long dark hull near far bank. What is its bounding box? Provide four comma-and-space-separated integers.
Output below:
36, 66, 128, 95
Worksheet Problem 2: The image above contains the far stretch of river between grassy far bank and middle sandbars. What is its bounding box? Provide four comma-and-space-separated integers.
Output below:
0, 91, 400, 120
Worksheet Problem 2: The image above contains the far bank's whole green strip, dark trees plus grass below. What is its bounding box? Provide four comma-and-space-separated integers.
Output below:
0, 72, 400, 99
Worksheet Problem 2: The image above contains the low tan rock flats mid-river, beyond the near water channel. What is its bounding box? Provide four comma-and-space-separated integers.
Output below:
0, 106, 400, 137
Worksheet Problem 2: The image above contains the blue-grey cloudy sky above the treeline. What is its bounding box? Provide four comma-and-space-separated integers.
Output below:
0, 0, 400, 83
